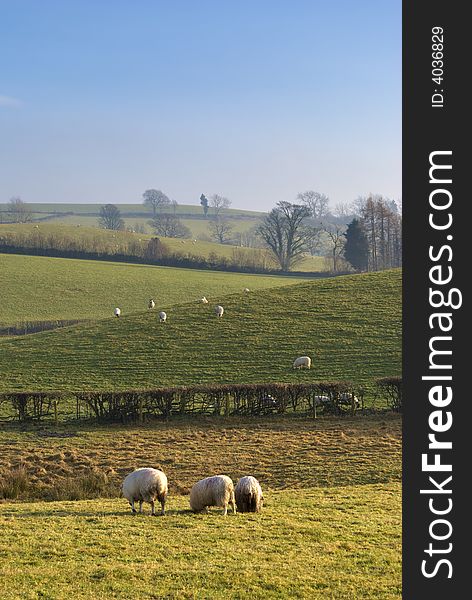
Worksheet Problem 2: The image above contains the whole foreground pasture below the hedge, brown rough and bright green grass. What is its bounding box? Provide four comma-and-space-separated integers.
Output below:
0, 414, 401, 600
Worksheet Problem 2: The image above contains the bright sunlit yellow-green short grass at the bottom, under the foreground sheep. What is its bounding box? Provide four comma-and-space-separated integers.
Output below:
0, 484, 401, 600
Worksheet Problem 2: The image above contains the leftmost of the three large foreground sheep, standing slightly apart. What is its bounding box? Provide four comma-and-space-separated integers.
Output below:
121, 467, 168, 516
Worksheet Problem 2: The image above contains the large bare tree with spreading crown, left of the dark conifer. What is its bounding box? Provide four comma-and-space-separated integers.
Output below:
257, 202, 310, 271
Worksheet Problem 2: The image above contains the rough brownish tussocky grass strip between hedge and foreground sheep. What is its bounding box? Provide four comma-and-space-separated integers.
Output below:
0, 414, 401, 499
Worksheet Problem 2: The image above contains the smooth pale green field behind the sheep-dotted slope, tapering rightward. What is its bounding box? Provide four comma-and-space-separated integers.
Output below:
0, 254, 310, 325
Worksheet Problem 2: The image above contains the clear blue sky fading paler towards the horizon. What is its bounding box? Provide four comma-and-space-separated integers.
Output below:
0, 0, 401, 210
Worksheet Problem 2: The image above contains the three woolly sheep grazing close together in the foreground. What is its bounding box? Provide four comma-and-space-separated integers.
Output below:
121, 467, 264, 516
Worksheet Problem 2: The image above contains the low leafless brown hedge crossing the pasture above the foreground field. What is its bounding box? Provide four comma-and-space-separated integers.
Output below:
0, 377, 401, 423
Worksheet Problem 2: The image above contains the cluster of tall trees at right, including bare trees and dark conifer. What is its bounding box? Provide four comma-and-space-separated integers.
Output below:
257, 191, 402, 272
